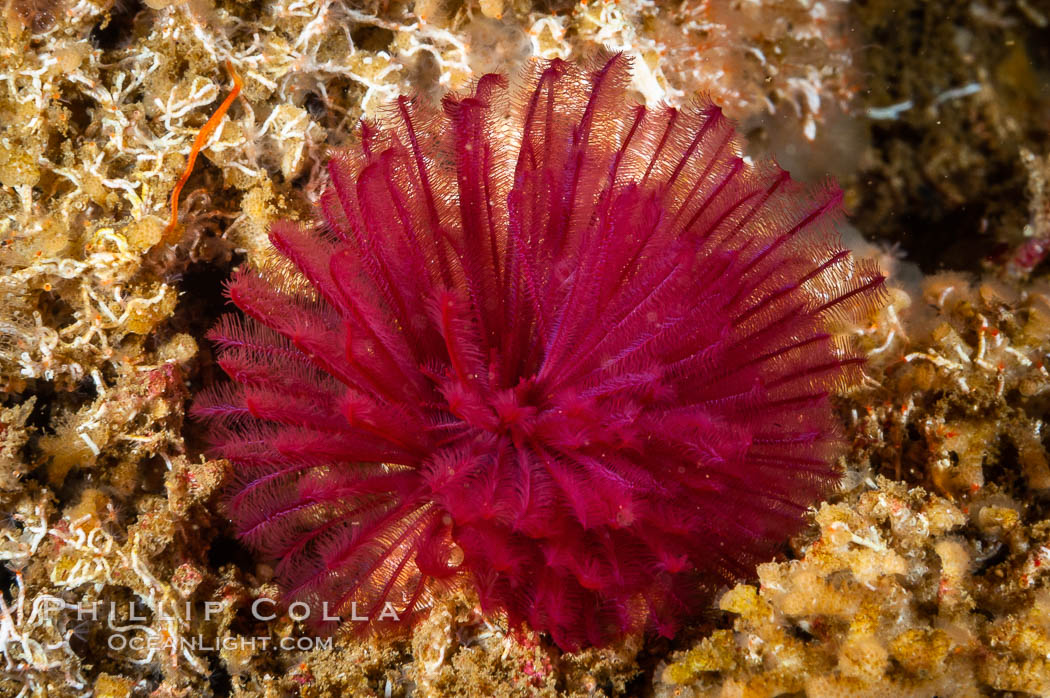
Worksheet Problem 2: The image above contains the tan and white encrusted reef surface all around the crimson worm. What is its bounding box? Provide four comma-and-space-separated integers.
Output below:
0, 0, 1050, 698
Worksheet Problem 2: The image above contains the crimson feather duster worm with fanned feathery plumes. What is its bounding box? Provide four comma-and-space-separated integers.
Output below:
194, 56, 882, 649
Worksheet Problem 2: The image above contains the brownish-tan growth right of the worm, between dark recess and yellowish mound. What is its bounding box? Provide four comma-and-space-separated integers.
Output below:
843, 273, 1050, 497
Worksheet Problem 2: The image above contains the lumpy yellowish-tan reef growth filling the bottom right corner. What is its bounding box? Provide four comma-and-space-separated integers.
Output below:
657, 478, 1050, 697
